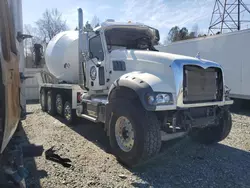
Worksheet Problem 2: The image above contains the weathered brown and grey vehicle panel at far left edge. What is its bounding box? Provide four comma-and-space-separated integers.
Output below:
0, 0, 21, 153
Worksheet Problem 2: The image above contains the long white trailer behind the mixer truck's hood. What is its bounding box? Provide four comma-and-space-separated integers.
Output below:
156, 29, 250, 100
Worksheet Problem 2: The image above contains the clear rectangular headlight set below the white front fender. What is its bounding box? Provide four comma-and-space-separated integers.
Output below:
146, 93, 173, 105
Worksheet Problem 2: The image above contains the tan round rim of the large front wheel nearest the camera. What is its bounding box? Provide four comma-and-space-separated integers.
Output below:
115, 116, 135, 152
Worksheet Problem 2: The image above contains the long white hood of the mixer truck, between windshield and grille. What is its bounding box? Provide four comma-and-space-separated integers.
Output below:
110, 49, 221, 92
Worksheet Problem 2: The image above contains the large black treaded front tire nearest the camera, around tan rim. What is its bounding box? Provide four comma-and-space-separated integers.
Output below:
109, 99, 161, 167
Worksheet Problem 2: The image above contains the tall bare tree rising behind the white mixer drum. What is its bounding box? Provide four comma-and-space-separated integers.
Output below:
36, 9, 68, 42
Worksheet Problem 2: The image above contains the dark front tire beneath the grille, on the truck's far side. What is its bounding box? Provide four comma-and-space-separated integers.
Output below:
189, 110, 232, 144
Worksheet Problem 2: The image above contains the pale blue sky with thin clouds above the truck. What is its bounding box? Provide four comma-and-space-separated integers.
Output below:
23, 0, 250, 39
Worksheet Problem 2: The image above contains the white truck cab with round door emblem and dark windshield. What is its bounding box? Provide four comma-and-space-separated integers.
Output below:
82, 22, 159, 94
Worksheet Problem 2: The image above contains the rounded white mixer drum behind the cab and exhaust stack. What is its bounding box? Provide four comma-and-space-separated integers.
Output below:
45, 31, 79, 83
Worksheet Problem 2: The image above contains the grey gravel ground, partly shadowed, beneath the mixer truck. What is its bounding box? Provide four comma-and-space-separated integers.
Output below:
19, 104, 250, 188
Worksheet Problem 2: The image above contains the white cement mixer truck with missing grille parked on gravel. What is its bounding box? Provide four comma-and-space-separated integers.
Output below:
40, 9, 233, 167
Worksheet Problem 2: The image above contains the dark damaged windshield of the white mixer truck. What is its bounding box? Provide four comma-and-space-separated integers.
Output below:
105, 26, 156, 52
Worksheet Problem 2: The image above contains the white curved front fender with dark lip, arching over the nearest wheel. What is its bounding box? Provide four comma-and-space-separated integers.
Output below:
109, 72, 175, 111
